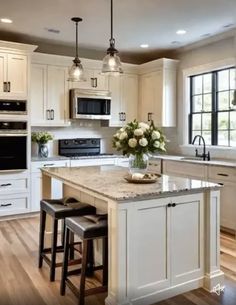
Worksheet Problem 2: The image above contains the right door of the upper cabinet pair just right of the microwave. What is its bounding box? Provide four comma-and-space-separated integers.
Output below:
121, 74, 138, 123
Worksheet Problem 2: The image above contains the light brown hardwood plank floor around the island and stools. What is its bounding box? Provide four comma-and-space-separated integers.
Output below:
0, 217, 236, 305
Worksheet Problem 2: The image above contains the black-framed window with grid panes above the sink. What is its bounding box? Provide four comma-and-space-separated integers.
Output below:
189, 68, 236, 147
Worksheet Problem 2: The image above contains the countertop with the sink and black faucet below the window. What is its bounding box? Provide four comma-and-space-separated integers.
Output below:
151, 155, 236, 168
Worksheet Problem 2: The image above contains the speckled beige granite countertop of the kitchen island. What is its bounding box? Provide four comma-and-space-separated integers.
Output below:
42, 165, 220, 202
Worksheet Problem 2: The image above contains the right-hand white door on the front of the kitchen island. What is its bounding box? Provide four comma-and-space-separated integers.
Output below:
170, 194, 204, 285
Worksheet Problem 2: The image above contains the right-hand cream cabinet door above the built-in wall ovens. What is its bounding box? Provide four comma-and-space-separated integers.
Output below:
7, 54, 28, 98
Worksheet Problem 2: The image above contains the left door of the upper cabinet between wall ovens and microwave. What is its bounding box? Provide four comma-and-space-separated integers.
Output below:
30, 64, 47, 126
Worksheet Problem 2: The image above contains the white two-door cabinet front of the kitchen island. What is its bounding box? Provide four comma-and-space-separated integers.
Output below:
128, 194, 204, 298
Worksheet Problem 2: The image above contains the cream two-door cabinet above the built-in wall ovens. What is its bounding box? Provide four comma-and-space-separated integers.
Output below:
0, 53, 28, 98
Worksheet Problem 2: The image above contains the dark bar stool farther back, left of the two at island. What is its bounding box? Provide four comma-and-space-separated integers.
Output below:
38, 198, 96, 282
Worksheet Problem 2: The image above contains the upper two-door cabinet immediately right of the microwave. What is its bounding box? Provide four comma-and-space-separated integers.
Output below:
109, 74, 138, 127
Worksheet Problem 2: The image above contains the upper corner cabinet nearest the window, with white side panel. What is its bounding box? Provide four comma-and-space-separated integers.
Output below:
139, 58, 178, 127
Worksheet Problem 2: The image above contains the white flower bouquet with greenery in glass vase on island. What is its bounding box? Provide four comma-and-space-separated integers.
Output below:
112, 120, 166, 169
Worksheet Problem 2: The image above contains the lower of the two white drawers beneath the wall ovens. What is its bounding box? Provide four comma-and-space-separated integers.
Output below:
0, 195, 29, 216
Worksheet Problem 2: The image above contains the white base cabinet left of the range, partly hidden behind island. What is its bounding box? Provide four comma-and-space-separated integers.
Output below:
30, 160, 70, 212
